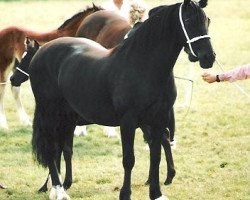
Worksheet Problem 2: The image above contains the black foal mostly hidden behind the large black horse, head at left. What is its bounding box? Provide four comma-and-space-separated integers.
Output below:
10, 35, 176, 192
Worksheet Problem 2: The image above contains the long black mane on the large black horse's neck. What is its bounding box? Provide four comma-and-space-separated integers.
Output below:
119, 4, 180, 54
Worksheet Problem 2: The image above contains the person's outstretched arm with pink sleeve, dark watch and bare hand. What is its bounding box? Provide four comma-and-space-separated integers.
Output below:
202, 64, 250, 83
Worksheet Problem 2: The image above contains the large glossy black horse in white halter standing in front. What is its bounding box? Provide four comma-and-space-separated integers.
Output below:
20, 0, 215, 200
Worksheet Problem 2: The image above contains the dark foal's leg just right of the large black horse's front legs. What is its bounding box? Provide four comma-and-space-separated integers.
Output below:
161, 129, 176, 185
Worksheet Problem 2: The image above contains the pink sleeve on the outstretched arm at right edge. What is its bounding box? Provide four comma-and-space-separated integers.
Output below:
219, 64, 250, 82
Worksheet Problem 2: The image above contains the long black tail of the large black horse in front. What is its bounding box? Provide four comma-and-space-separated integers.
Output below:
32, 105, 55, 167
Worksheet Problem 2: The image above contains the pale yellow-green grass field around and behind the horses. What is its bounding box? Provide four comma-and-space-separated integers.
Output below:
0, 0, 250, 200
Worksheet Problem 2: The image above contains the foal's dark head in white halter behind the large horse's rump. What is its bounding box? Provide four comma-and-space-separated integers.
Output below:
10, 38, 40, 87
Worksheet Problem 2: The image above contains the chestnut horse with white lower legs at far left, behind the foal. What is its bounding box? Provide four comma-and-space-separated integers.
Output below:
0, 4, 102, 128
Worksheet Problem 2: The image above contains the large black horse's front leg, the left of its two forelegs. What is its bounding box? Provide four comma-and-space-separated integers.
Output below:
119, 115, 136, 200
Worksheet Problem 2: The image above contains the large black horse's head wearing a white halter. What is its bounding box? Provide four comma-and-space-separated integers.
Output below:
179, 0, 215, 68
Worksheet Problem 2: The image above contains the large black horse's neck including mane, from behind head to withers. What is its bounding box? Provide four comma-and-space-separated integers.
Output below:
115, 4, 184, 75
